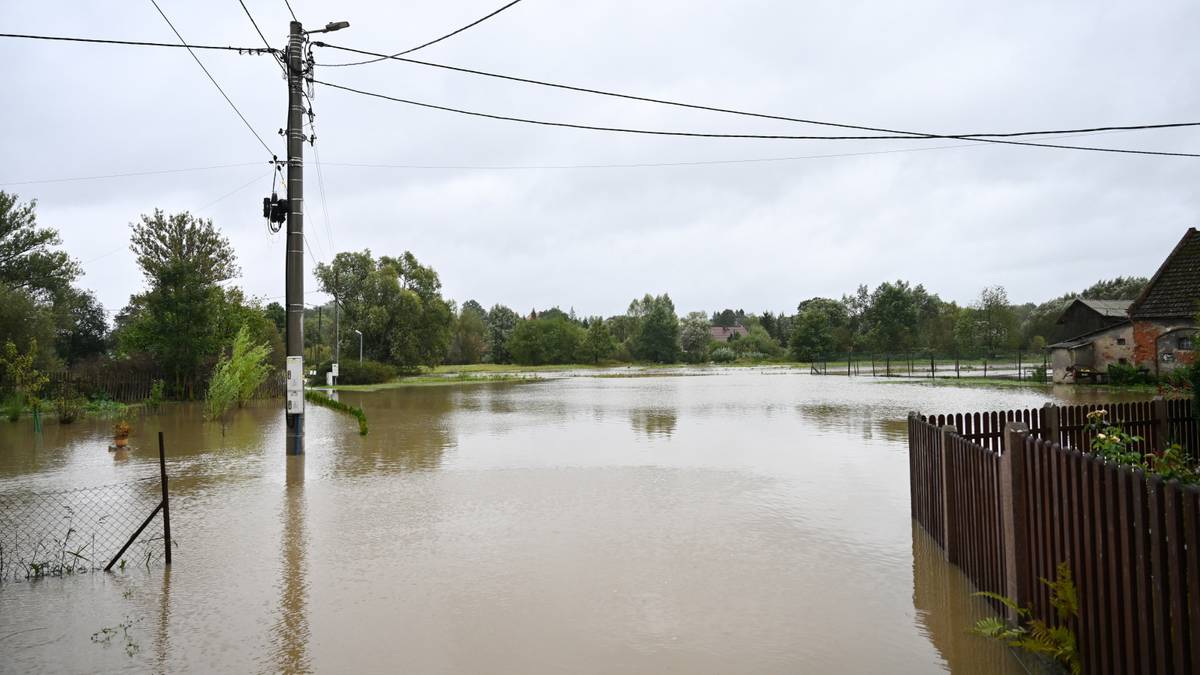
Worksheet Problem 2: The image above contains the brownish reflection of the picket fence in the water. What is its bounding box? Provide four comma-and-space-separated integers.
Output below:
912, 520, 1025, 674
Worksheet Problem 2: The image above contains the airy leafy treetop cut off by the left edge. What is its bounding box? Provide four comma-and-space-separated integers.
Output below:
0, 191, 79, 301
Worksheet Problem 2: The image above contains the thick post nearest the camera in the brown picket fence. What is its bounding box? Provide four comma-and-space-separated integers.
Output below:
1000, 422, 1032, 621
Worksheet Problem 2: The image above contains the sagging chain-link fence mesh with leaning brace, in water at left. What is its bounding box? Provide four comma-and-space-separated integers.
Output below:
0, 476, 166, 583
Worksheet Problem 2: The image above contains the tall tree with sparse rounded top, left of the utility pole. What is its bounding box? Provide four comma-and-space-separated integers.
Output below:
118, 209, 240, 395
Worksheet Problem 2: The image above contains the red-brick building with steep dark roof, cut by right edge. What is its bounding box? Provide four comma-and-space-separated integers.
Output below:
1129, 227, 1200, 375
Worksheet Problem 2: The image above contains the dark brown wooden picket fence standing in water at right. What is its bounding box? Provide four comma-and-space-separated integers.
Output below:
908, 401, 1200, 675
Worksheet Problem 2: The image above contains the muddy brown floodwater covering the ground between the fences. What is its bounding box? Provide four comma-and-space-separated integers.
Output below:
0, 369, 1142, 674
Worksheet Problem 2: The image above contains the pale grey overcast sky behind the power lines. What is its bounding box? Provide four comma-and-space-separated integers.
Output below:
0, 0, 1200, 315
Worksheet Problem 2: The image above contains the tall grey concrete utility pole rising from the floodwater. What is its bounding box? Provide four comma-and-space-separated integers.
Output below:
286, 22, 305, 455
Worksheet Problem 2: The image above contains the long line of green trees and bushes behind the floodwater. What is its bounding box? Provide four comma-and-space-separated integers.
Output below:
0, 192, 1146, 398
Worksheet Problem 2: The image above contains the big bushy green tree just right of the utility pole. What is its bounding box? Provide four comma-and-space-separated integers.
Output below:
316, 250, 454, 369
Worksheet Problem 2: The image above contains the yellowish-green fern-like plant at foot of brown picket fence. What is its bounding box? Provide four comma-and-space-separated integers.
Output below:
972, 562, 1084, 675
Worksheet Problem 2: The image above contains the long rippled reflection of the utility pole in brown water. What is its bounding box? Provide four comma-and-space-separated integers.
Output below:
270, 455, 312, 673
